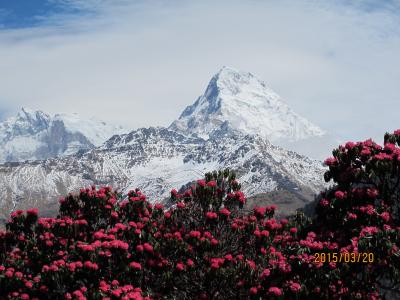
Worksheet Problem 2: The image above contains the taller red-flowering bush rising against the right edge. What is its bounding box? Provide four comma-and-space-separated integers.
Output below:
313, 130, 400, 298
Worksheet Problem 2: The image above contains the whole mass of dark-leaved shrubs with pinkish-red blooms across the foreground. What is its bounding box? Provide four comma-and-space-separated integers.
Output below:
0, 135, 400, 299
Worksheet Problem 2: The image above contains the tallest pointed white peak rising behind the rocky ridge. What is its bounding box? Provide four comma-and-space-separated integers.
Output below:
169, 67, 337, 158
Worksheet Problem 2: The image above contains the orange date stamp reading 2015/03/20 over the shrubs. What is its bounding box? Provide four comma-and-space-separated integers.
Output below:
314, 252, 375, 264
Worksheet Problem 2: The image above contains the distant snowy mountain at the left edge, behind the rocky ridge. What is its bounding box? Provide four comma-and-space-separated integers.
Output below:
0, 108, 124, 162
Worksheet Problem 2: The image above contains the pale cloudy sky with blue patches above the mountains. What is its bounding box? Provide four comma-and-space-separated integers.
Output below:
0, 0, 400, 145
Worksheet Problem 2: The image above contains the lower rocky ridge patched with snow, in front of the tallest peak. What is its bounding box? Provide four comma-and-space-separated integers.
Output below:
0, 126, 324, 223
